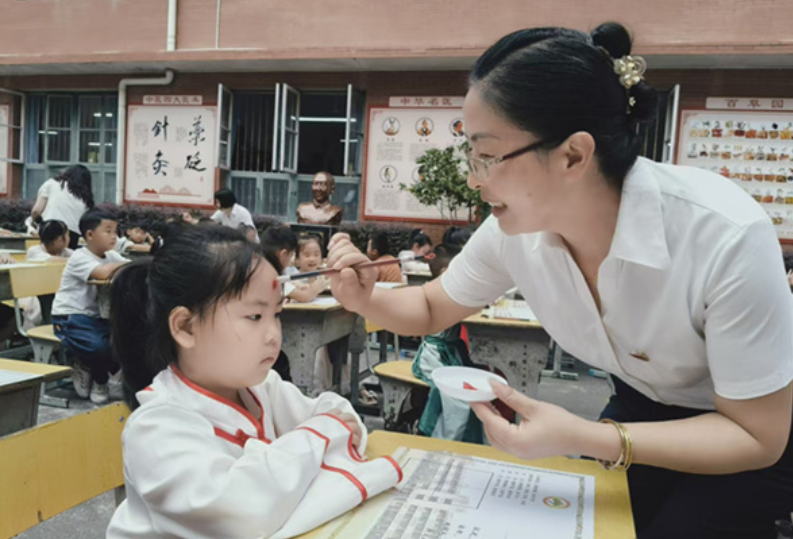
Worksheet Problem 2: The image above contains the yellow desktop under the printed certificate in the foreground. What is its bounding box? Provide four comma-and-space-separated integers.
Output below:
300, 430, 636, 539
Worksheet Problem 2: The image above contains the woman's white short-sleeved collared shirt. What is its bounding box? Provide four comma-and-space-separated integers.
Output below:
441, 159, 793, 410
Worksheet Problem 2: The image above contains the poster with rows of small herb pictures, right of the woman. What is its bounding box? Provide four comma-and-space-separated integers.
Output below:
677, 110, 793, 240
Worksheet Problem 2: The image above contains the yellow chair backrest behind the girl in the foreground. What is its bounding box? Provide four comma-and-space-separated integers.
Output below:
0, 402, 129, 539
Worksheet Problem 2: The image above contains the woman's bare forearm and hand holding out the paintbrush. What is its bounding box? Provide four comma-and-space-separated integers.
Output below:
328, 234, 481, 335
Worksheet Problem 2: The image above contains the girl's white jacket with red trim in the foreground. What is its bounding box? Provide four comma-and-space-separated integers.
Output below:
107, 367, 402, 539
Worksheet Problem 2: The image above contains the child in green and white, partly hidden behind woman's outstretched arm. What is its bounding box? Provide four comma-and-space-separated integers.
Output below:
413, 244, 484, 444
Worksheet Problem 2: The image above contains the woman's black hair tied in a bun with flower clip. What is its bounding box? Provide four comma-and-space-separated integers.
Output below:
469, 22, 657, 190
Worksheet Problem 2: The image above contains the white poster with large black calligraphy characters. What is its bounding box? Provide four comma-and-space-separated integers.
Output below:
124, 106, 216, 207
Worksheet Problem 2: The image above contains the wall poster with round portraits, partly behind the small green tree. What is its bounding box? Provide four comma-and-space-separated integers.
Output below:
363, 107, 465, 222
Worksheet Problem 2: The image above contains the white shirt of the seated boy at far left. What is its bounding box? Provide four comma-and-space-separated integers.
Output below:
52, 247, 128, 318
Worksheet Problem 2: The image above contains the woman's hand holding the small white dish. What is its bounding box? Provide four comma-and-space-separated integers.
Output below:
471, 381, 588, 460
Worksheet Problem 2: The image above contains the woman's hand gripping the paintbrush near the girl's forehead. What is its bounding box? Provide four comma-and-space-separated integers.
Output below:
328, 233, 377, 312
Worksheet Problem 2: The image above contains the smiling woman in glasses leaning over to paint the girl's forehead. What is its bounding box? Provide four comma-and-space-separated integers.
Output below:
329, 23, 793, 539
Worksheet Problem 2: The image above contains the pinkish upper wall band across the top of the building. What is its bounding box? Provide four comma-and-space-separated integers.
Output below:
0, 0, 793, 64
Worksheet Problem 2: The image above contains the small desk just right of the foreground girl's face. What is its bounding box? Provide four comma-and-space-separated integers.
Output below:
281, 303, 358, 392
